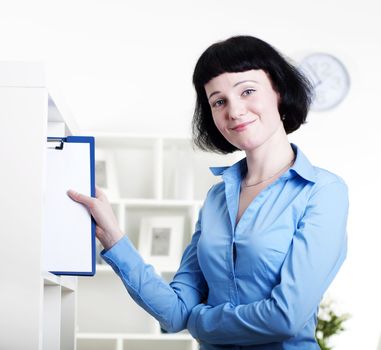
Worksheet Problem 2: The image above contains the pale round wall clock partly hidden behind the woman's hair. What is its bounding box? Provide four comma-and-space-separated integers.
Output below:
300, 53, 350, 111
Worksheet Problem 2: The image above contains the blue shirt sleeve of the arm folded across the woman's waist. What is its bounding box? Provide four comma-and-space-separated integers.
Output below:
187, 180, 348, 345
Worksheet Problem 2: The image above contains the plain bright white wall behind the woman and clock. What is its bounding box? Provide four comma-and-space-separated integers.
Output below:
0, 0, 381, 350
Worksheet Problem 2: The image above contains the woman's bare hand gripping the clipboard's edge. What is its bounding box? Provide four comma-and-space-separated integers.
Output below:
67, 186, 123, 249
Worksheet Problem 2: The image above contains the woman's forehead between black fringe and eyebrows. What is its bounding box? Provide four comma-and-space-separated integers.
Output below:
205, 69, 271, 93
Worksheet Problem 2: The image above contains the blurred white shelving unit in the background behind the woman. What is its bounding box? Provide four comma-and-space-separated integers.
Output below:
77, 131, 242, 350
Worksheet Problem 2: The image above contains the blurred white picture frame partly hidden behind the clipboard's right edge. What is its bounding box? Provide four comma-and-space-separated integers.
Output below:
95, 148, 119, 198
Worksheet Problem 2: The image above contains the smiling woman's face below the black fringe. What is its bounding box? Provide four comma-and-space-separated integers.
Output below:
205, 70, 283, 151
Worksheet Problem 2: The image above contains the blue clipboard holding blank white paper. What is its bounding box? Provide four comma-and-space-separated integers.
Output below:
42, 136, 96, 276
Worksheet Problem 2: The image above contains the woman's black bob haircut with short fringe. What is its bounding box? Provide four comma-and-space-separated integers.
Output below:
192, 36, 312, 154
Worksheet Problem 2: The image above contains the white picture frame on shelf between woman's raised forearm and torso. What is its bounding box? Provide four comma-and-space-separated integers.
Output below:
138, 216, 184, 271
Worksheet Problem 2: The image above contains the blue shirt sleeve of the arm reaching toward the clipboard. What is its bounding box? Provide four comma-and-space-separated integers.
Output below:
102, 209, 207, 332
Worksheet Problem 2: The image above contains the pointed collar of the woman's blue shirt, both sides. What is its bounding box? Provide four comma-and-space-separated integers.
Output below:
209, 143, 316, 182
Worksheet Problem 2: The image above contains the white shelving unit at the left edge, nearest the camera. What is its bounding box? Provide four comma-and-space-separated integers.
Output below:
0, 62, 77, 350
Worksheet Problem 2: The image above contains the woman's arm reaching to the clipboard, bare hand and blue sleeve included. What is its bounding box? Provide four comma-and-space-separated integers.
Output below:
68, 188, 207, 332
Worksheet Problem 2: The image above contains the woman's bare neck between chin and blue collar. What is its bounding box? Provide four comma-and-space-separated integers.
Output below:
245, 128, 295, 184
